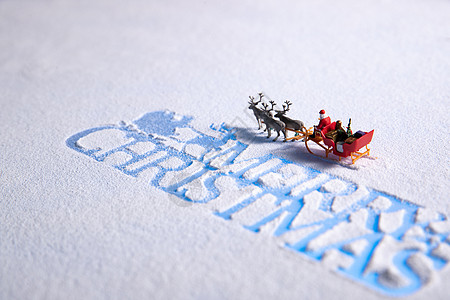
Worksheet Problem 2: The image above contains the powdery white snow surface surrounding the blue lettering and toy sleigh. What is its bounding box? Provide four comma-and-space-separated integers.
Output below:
0, 0, 450, 299
